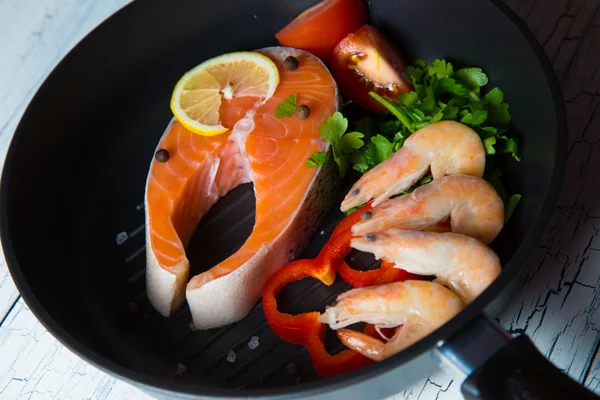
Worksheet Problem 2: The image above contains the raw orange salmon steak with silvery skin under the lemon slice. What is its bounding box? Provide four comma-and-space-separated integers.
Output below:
145, 47, 339, 329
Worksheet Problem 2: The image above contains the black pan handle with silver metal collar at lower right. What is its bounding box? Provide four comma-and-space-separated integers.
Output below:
438, 316, 600, 400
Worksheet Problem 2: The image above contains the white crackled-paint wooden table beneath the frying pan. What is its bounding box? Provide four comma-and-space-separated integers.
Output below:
0, 0, 600, 400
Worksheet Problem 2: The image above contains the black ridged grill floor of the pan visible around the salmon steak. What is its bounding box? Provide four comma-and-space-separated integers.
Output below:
115, 184, 350, 389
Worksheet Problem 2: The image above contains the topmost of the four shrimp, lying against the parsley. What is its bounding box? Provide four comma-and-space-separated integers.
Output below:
341, 121, 485, 211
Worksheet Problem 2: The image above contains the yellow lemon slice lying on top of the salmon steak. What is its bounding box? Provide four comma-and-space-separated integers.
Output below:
171, 51, 279, 136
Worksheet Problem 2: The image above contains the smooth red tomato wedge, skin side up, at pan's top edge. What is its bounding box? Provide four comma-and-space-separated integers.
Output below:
275, 0, 367, 65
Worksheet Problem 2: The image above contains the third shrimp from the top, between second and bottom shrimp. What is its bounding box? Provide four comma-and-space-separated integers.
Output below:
350, 229, 501, 304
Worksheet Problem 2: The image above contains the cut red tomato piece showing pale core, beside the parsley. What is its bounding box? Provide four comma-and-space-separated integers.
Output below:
331, 25, 413, 112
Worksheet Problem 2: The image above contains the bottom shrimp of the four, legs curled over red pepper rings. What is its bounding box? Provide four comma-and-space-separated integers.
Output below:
319, 280, 463, 361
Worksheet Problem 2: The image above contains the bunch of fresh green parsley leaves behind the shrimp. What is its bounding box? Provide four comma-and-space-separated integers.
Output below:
306, 59, 521, 219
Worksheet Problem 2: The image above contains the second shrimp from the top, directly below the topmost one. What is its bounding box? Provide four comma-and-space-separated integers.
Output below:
352, 175, 504, 244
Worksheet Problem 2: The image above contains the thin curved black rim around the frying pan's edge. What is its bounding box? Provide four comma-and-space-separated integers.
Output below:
0, 0, 567, 399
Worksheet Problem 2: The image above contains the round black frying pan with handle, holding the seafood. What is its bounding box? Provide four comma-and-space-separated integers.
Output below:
0, 0, 592, 399
